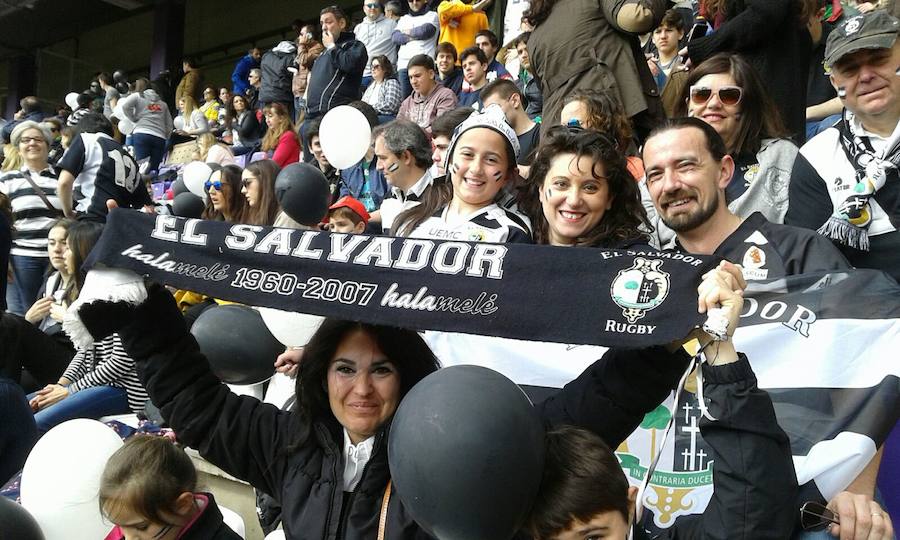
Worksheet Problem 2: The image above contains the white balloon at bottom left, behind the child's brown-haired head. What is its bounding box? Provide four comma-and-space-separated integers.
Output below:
21, 418, 122, 540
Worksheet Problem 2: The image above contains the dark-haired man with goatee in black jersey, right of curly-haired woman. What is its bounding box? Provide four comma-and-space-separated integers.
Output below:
643, 118, 885, 539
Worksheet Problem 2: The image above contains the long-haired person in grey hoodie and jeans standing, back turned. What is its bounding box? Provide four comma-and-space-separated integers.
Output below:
122, 77, 174, 171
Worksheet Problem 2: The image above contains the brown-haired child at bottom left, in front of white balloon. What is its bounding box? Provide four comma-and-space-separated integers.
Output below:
100, 435, 241, 540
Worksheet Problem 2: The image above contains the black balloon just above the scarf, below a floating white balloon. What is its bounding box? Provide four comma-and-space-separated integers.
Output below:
275, 163, 331, 225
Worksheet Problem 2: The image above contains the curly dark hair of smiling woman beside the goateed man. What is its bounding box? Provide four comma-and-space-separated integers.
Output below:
519, 126, 652, 248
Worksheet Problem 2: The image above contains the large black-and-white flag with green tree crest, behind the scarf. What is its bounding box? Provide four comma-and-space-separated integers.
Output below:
426, 270, 900, 528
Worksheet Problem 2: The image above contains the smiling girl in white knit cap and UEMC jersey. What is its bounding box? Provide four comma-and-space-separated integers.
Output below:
392, 105, 532, 243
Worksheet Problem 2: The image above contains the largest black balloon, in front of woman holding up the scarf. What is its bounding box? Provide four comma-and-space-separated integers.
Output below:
388, 366, 544, 540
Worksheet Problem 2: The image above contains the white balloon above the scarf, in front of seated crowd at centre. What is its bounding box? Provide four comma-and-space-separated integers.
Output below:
319, 105, 372, 169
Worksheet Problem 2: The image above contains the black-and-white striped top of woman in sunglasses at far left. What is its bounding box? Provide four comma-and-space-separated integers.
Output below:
0, 166, 62, 258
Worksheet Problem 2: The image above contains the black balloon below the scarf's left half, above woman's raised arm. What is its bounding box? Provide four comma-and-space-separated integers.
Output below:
191, 305, 284, 384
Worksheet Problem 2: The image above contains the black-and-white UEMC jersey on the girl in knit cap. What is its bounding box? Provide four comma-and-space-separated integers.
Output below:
409, 204, 532, 244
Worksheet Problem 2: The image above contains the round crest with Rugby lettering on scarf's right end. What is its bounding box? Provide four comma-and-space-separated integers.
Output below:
606, 257, 670, 334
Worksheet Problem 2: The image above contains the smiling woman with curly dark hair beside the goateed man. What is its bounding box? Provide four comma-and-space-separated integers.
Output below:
519, 126, 649, 249
